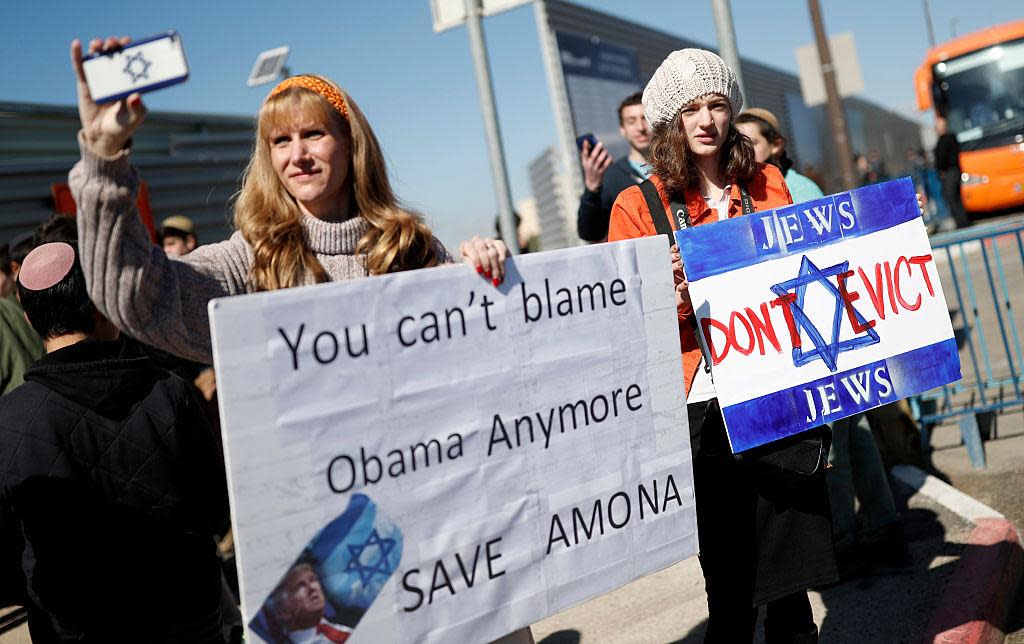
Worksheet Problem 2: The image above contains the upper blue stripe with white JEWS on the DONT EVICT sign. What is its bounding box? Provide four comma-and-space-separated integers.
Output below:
676, 177, 921, 282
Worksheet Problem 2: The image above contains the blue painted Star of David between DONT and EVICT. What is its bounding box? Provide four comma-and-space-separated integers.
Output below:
771, 255, 880, 373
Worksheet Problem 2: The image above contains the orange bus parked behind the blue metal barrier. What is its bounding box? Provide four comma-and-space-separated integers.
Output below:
914, 20, 1024, 212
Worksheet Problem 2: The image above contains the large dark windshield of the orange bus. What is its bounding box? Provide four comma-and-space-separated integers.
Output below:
934, 39, 1024, 149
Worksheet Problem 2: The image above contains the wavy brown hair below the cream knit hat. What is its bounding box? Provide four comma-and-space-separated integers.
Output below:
650, 99, 758, 195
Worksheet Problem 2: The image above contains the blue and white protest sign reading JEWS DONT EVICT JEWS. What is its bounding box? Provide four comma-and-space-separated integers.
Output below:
676, 179, 961, 452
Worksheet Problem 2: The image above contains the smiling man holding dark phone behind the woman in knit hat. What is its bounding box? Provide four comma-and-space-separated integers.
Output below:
577, 92, 650, 242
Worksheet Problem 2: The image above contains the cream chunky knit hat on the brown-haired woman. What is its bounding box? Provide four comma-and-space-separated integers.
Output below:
643, 49, 743, 128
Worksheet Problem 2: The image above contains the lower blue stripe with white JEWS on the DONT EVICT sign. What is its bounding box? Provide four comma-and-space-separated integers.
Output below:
722, 338, 961, 452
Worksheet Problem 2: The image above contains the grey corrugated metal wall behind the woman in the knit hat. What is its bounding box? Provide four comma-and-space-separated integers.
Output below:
544, 0, 921, 194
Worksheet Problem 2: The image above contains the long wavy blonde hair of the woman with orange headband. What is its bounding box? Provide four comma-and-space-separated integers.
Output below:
234, 77, 437, 291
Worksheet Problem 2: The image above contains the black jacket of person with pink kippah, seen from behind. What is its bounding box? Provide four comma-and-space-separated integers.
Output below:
0, 340, 228, 642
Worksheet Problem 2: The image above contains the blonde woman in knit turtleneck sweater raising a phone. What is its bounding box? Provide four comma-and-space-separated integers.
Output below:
69, 37, 508, 363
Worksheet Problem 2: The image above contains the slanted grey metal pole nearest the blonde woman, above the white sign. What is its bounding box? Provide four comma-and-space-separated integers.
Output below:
466, 0, 519, 255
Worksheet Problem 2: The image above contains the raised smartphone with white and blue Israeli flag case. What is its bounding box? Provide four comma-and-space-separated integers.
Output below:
82, 30, 188, 103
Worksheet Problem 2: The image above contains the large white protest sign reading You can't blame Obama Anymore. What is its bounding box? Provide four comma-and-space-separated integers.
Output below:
210, 239, 696, 644
